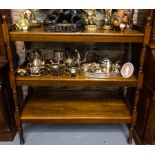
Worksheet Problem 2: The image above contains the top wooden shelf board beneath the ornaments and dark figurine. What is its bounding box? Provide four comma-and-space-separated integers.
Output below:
10, 26, 144, 43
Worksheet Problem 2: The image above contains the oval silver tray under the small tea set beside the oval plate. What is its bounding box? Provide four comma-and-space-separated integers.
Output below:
81, 71, 120, 79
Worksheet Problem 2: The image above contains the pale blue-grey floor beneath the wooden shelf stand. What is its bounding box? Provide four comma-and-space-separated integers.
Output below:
0, 124, 135, 145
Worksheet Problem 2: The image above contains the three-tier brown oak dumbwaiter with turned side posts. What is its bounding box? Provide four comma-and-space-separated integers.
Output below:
2, 10, 151, 144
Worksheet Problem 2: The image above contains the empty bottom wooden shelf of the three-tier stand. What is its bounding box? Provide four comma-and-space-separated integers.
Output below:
21, 91, 131, 123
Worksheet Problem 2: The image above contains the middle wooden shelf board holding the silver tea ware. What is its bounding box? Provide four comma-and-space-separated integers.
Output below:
16, 74, 137, 87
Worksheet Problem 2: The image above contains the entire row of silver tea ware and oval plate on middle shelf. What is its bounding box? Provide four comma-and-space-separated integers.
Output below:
17, 48, 134, 78
